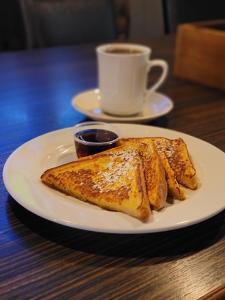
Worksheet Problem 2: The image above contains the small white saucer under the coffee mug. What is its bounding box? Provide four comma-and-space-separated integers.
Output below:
72, 89, 173, 123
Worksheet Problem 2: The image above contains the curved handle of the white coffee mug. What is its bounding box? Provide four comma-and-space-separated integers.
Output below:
146, 59, 169, 96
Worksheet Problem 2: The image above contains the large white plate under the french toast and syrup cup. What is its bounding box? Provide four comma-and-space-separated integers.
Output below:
3, 124, 225, 233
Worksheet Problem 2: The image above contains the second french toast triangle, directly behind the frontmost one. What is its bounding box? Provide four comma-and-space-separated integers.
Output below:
119, 138, 167, 210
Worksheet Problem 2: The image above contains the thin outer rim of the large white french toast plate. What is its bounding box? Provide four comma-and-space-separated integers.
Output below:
3, 123, 225, 234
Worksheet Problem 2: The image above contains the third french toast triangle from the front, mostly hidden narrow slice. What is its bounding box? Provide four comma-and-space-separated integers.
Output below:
119, 137, 186, 200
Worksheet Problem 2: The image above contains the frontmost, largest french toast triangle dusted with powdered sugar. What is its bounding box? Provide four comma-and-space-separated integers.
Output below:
41, 145, 151, 221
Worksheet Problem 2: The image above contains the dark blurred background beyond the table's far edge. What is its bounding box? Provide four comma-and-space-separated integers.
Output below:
0, 0, 225, 51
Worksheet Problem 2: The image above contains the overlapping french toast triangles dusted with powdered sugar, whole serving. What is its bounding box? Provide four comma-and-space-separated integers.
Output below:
41, 137, 198, 221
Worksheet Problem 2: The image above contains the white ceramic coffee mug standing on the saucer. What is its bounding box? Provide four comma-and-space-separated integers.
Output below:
96, 43, 168, 116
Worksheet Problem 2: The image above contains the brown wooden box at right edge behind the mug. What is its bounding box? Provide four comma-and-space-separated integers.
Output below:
174, 20, 225, 90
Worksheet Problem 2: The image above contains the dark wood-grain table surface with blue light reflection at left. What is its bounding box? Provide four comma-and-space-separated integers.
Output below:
0, 36, 225, 299
